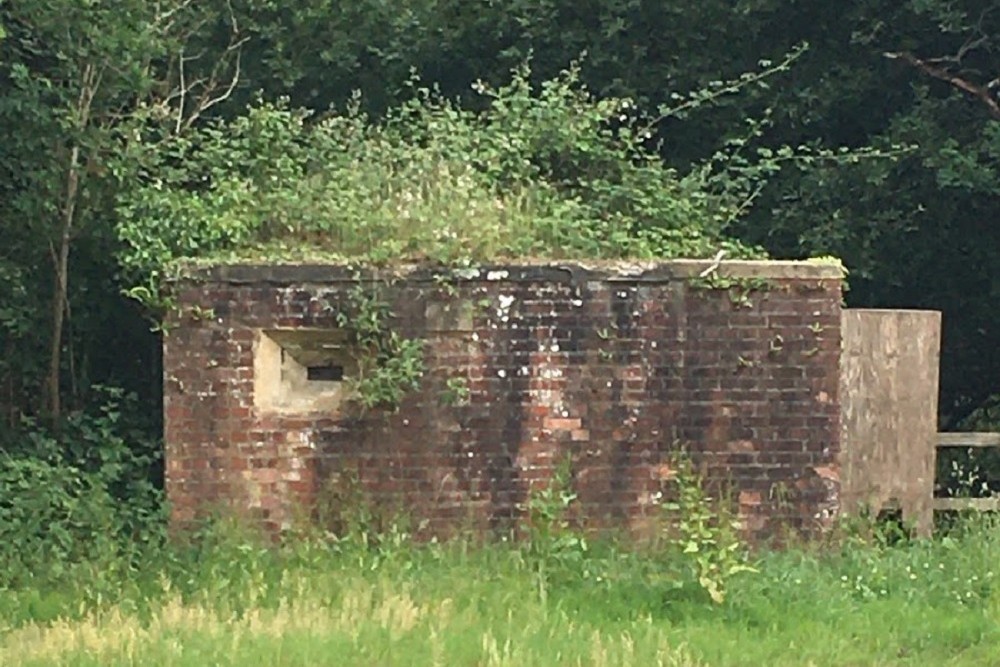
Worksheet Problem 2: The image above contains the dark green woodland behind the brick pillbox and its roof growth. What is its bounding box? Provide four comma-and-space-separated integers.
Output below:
0, 0, 1000, 521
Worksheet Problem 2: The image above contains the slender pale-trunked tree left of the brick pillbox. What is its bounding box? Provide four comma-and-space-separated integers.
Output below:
0, 0, 245, 424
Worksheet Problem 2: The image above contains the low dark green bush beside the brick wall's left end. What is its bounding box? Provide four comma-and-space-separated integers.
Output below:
0, 389, 164, 587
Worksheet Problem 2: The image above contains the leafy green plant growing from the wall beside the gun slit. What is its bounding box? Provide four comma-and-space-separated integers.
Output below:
337, 283, 424, 411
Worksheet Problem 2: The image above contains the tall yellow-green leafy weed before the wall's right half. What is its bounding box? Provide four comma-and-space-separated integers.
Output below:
663, 455, 756, 604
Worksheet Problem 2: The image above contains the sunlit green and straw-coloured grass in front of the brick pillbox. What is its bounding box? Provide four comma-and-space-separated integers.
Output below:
0, 522, 1000, 667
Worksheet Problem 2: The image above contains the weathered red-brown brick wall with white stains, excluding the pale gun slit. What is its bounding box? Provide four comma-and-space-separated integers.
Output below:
164, 261, 841, 537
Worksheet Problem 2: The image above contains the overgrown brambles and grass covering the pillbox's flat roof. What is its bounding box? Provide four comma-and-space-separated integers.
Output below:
111, 65, 773, 310
